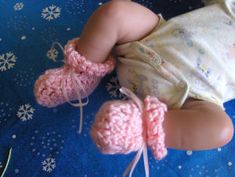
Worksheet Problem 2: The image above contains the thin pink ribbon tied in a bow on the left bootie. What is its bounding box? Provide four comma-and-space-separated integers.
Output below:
52, 42, 89, 134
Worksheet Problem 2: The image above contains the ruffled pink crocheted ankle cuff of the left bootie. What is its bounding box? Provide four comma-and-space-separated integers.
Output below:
64, 38, 115, 77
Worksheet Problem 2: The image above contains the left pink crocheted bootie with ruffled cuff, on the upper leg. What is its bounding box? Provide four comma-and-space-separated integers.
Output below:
34, 38, 115, 107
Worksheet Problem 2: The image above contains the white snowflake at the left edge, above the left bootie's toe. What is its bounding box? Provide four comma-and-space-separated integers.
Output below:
0, 52, 16, 72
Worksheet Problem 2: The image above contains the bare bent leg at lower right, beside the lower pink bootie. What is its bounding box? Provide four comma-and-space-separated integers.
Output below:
164, 100, 233, 150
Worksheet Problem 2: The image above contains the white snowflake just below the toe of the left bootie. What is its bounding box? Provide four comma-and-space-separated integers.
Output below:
17, 104, 35, 121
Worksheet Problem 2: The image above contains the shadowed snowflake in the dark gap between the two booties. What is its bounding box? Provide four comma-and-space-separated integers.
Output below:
106, 77, 124, 98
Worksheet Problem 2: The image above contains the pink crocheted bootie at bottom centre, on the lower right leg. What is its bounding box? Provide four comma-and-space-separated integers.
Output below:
91, 88, 167, 159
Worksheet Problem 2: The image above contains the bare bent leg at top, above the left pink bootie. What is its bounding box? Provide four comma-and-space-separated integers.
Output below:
77, 0, 159, 62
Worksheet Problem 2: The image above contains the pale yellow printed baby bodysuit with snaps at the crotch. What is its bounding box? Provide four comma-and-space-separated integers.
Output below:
116, 0, 235, 108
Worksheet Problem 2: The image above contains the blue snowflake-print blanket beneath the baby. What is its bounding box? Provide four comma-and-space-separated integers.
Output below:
0, 0, 235, 177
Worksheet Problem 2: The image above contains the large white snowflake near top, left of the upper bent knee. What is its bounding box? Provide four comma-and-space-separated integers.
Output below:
42, 4, 61, 21
